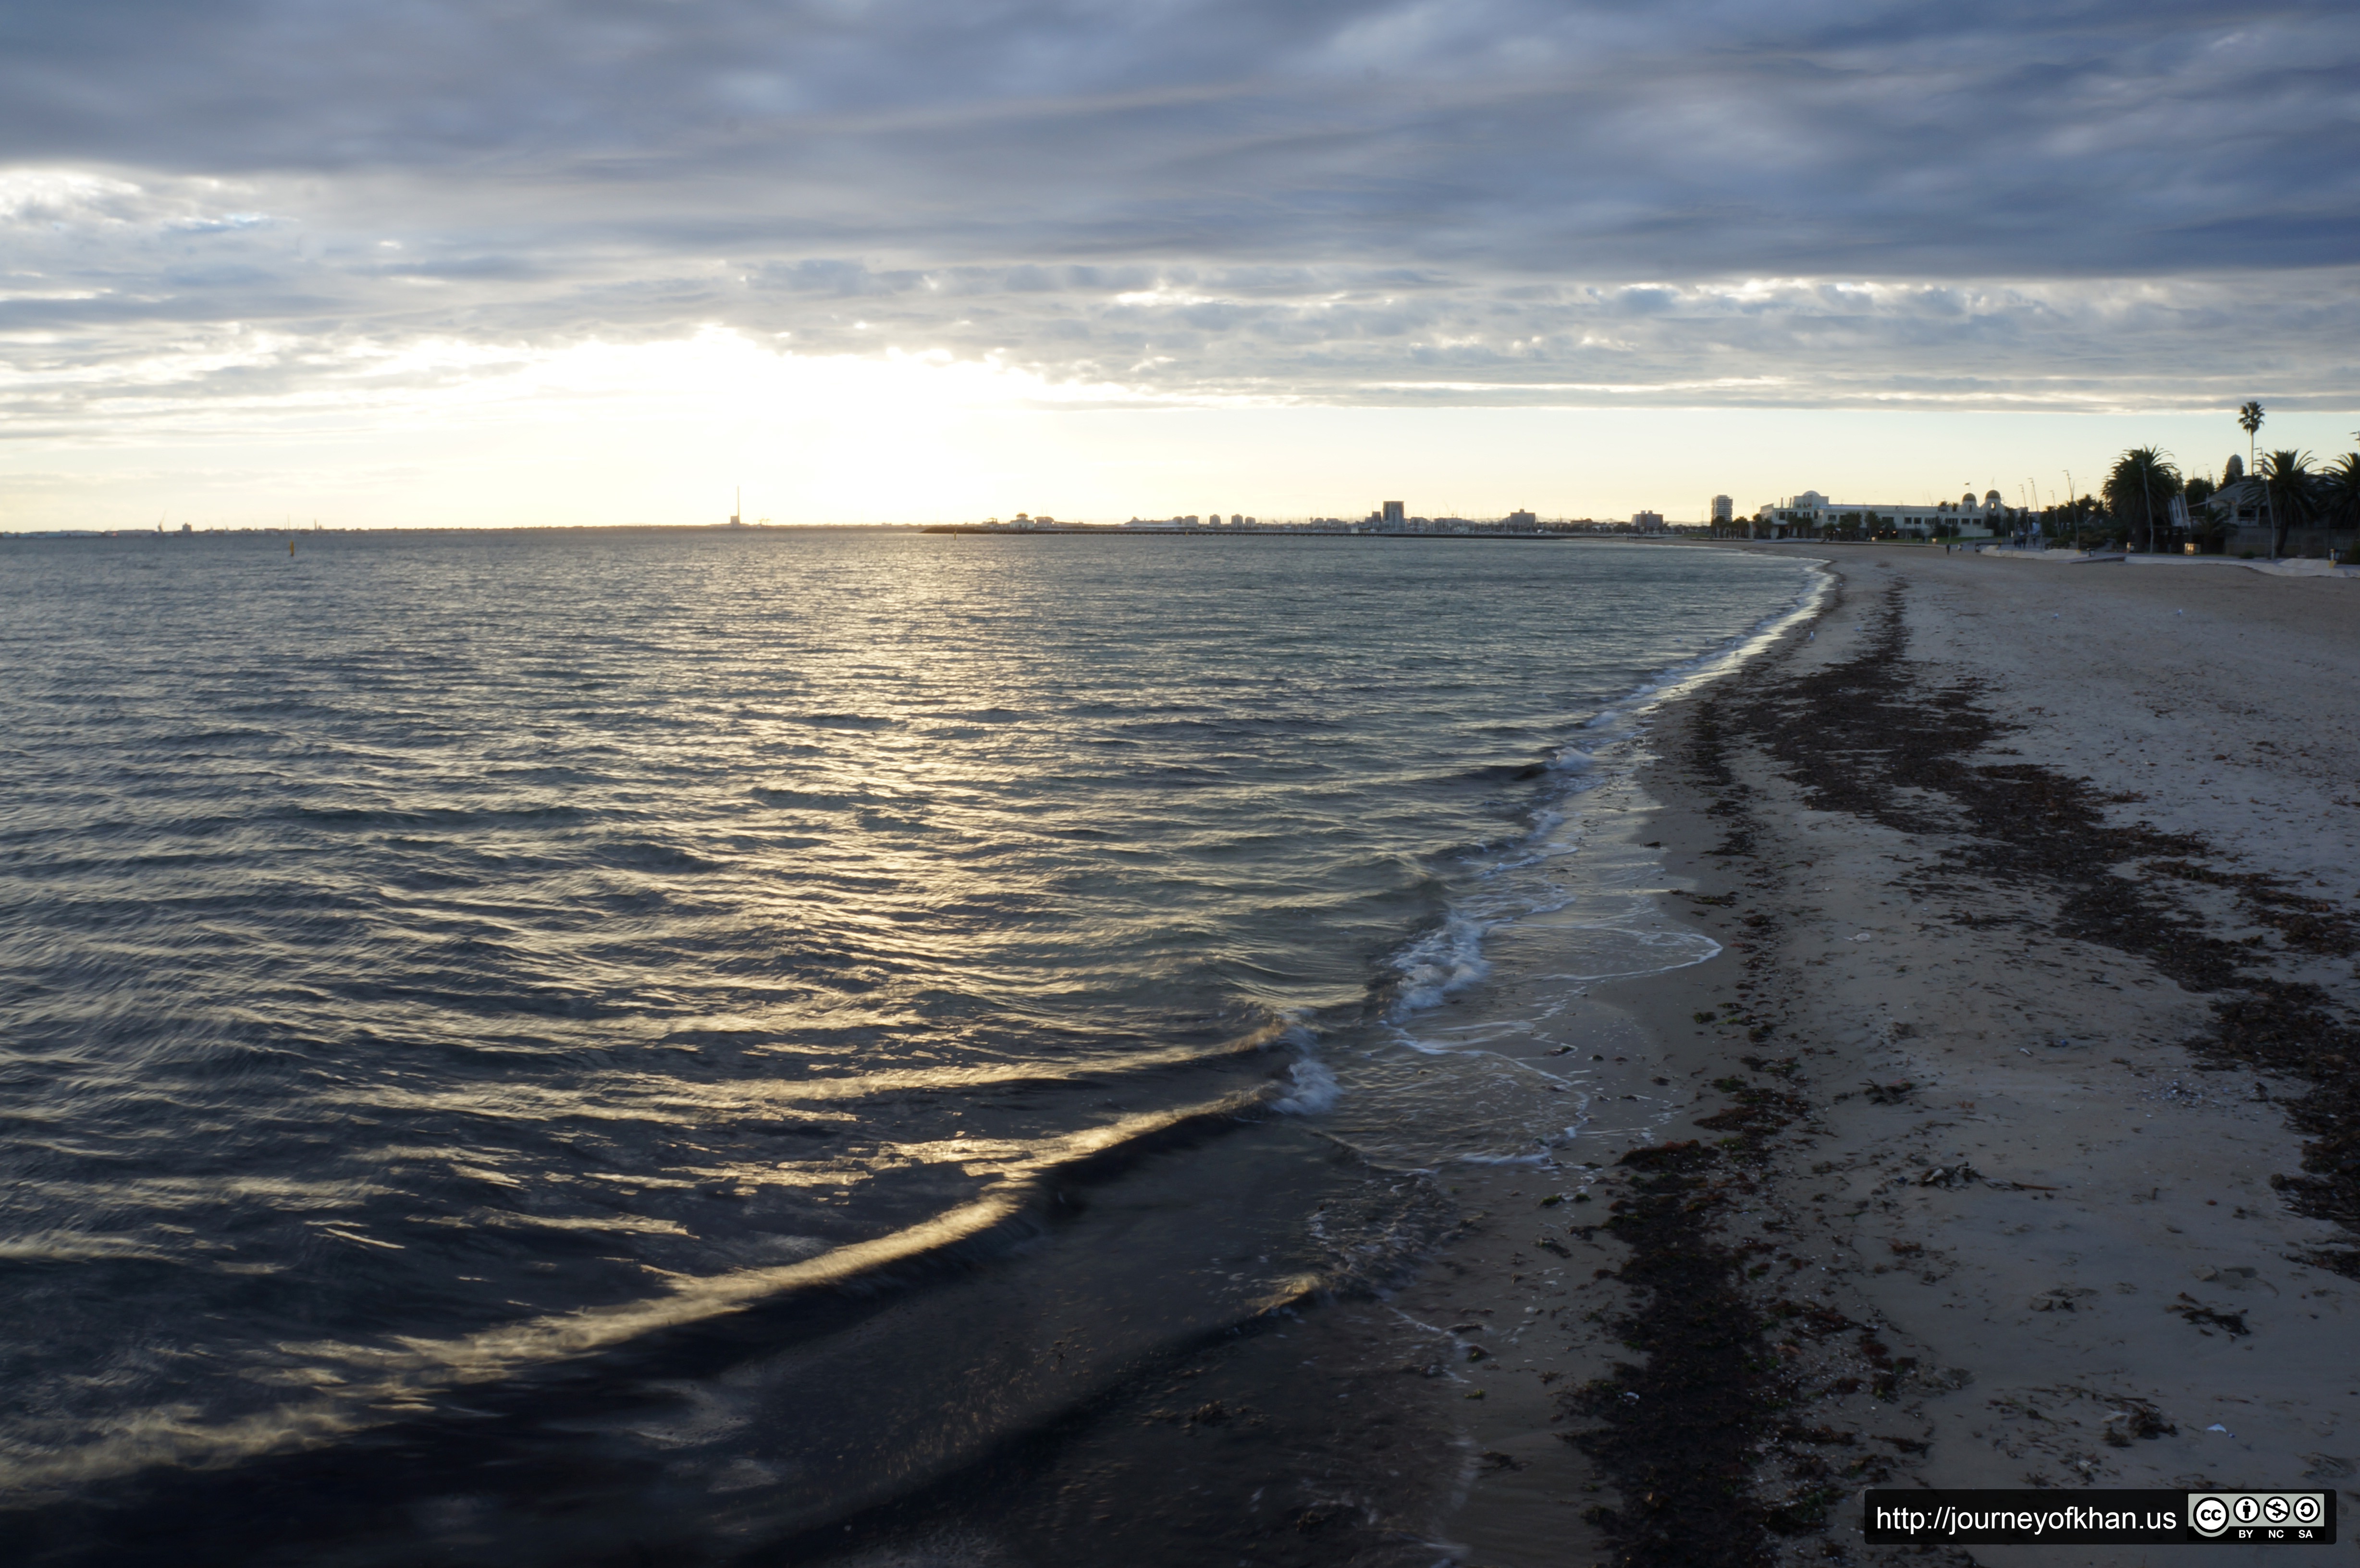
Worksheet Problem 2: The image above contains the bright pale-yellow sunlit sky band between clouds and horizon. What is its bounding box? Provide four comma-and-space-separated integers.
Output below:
10, 326, 2341, 527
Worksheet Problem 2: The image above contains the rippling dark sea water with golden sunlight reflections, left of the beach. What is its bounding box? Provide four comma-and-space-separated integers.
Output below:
0, 531, 1815, 1563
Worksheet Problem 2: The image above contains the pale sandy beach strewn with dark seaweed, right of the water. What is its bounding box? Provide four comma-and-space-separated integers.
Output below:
1397, 548, 2360, 1568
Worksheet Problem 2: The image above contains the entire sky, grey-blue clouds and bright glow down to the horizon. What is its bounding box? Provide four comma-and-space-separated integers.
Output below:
0, 0, 2360, 529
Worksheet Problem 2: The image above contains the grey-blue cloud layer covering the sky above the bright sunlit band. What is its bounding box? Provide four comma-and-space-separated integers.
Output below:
0, 0, 2360, 437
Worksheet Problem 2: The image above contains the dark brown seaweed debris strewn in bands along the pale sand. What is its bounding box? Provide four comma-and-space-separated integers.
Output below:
1562, 581, 2360, 1568
